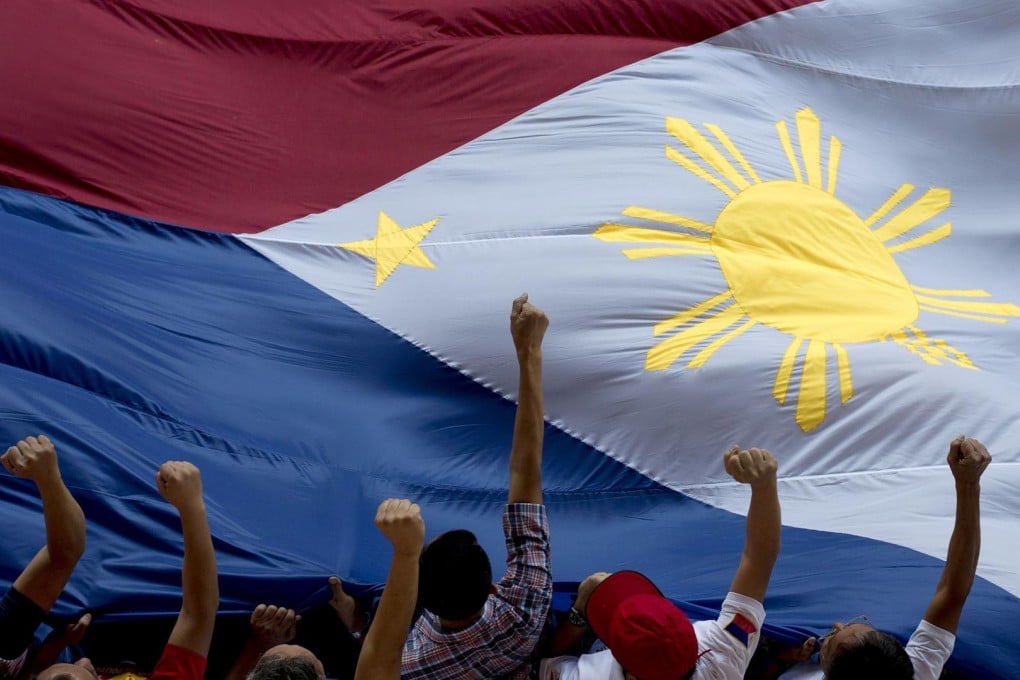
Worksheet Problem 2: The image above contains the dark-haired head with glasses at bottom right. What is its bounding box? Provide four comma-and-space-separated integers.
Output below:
818, 623, 914, 680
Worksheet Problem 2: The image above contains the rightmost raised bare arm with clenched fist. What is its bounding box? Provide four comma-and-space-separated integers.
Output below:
924, 436, 991, 634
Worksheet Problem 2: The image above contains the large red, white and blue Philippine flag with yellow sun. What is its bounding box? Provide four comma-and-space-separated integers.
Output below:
0, 0, 1020, 678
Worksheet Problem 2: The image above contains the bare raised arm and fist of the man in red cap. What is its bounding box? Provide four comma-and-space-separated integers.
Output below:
723, 447, 782, 603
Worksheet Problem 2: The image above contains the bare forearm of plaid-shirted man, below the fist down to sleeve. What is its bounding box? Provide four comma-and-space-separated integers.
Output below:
508, 350, 545, 503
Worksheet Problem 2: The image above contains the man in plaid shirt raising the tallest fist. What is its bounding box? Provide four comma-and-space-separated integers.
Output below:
401, 294, 553, 680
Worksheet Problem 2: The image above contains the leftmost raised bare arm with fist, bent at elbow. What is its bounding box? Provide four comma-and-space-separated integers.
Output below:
0, 434, 85, 612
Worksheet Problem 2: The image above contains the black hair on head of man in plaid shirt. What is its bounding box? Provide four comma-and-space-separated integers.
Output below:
418, 529, 493, 619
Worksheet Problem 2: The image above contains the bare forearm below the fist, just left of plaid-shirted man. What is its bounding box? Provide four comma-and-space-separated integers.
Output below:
354, 554, 418, 680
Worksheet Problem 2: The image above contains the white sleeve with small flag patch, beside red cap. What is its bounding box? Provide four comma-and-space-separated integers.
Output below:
695, 592, 765, 680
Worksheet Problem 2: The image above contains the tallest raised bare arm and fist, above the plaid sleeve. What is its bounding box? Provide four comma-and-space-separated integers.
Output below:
507, 293, 549, 504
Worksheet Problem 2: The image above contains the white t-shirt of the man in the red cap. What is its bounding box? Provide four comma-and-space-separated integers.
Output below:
539, 592, 765, 680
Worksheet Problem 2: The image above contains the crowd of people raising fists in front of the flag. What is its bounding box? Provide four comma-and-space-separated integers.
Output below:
0, 296, 990, 680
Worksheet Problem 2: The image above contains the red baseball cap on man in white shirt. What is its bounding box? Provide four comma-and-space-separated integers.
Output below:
584, 571, 699, 680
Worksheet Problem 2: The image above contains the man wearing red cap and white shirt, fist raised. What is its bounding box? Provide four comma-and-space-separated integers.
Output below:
541, 447, 782, 680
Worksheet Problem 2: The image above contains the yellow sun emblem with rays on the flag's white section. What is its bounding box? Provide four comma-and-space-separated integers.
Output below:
594, 108, 1020, 432
